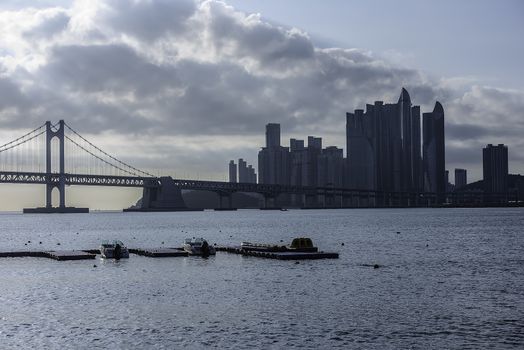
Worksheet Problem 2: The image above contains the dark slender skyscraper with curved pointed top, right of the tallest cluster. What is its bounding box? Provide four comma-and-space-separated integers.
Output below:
423, 101, 447, 203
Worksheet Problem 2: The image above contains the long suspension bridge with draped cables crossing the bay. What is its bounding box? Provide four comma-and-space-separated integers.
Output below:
0, 120, 506, 213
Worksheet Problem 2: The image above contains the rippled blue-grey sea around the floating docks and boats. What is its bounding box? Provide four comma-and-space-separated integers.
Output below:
0, 208, 524, 349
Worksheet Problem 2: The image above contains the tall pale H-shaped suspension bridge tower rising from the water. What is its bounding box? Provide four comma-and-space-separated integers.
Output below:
45, 120, 65, 209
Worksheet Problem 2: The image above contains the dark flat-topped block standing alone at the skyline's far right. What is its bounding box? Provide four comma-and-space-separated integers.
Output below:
482, 144, 508, 193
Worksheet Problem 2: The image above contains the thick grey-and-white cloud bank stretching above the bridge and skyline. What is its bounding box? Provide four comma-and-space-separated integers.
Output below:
0, 0, 524, 178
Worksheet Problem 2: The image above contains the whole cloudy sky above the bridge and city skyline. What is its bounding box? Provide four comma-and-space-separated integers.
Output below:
0, 0, 524, 210
